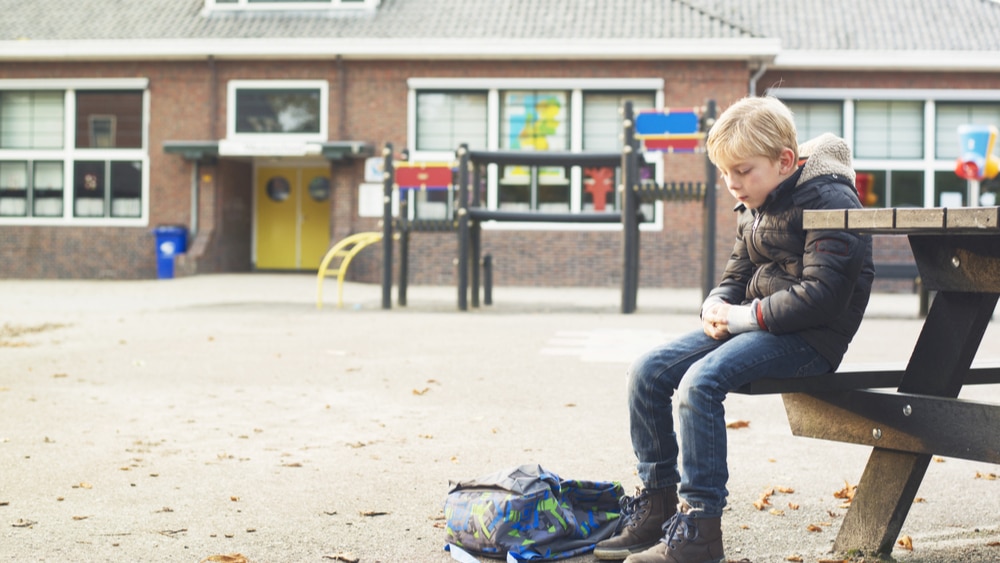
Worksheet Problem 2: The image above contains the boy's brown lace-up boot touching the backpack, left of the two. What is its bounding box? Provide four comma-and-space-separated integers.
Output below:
594, 487, 677, 561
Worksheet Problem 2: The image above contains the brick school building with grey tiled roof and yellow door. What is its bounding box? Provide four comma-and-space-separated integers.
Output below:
0, 0, 1000, 287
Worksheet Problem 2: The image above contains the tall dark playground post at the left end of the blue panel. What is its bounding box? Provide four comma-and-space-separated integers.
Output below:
618, 101, 639, 314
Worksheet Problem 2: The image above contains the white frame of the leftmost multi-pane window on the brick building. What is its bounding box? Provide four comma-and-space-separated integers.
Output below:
0, 78, 150, 227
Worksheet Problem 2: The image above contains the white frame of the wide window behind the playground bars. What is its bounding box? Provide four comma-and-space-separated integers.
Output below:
406, 77, 664, 231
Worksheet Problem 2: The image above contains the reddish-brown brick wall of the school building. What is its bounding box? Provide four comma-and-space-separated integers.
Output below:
9, 60, 976, 287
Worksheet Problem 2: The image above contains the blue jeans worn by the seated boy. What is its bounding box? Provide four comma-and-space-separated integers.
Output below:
628, 330, 830, 517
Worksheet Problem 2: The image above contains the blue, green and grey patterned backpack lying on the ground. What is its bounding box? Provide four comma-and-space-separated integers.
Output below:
444, 465, 623, 561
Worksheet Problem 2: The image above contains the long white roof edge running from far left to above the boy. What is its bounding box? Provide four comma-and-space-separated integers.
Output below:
0, 38, 781, 61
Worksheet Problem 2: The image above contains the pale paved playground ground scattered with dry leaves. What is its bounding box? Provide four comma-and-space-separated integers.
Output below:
0, 273, 1000, 563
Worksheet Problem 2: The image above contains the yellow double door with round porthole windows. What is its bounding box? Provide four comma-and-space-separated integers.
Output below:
254, 166, 331, 270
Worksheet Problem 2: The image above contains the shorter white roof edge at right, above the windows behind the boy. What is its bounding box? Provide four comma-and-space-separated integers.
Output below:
770, 50, 1000, 72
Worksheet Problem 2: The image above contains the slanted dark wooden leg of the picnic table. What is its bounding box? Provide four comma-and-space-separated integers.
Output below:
833, 291, 997, 553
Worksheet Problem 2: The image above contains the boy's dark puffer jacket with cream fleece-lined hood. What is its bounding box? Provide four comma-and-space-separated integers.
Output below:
705, 134, 875, 369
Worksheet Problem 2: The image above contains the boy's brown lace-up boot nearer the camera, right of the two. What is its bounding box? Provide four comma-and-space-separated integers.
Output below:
625, 512, 725, 563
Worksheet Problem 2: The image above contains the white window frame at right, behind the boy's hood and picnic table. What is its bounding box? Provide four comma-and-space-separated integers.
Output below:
767, 87, 1000, 207
